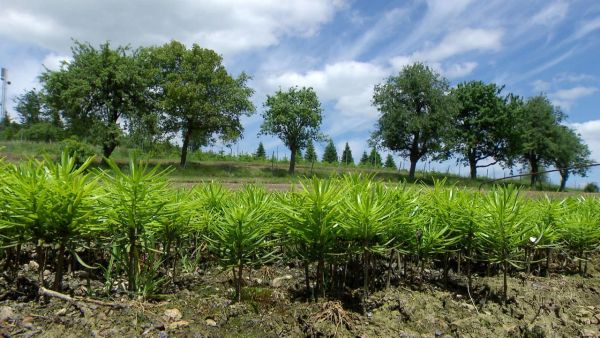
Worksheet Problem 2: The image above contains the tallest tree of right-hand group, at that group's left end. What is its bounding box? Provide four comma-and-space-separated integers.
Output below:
372, 63, 455, 179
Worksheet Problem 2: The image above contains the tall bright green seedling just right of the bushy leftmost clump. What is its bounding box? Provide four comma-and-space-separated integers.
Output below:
103, 159, 173, 293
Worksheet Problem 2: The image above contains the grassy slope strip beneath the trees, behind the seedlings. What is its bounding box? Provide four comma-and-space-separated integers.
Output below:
0, 141, 580, 192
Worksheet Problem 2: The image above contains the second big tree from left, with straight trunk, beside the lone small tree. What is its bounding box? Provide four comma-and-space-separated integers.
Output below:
145, 41, 255, 166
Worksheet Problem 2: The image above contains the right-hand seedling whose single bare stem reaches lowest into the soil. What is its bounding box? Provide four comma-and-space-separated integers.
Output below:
481, 185, 529, 302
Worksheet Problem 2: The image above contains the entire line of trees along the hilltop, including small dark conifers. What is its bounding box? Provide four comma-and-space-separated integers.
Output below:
8, 41, 590, 189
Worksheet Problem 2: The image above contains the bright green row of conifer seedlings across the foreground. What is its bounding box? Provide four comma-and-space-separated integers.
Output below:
0, 154, 600, 300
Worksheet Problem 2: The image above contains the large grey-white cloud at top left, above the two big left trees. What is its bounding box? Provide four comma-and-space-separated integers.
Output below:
0, 0, 344, 54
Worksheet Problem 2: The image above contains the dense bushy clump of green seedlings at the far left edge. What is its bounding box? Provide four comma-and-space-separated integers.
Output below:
2, 152, 97, 290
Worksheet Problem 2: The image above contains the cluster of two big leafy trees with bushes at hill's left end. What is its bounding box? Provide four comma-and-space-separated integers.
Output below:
11, 41, 255, 166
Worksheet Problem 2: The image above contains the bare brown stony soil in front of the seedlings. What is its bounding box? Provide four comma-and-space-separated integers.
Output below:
0, 262, 600, 338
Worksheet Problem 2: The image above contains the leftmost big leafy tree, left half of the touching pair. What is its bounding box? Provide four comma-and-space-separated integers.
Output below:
40, 42, 148, 157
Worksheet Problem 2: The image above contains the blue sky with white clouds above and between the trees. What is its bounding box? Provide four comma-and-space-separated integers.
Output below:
0, 0, 600, 186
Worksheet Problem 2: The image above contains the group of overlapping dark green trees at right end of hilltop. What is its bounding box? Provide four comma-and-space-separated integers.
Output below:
371, 63, 591, 190
